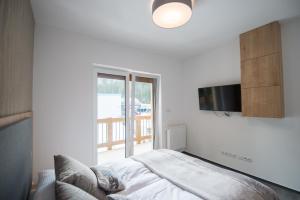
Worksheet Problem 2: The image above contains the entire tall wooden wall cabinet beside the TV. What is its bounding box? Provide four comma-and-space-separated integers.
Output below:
240, 22, 284, 118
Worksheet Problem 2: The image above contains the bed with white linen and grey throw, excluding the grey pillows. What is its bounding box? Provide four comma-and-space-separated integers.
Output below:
33, 149, 278, 200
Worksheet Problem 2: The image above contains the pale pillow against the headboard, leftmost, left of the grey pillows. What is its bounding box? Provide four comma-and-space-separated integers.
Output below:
33, 169, 55, 200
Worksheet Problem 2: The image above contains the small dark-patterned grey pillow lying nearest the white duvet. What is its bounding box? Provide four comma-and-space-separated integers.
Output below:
91, 166, 125, 194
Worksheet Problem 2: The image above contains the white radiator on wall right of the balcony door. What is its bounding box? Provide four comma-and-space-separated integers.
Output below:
167, 125, 186, 151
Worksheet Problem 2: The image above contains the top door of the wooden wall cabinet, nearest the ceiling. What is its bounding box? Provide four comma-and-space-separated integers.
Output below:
240, 22, 281, 61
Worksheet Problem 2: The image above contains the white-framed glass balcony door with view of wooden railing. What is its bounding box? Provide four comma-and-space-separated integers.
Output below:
95, 69, 156, 164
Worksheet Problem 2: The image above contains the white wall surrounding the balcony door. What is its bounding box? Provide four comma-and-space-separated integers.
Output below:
33, 25, 182, 178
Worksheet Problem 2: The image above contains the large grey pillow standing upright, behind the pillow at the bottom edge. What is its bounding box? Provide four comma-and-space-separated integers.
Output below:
54, 155, 107, 200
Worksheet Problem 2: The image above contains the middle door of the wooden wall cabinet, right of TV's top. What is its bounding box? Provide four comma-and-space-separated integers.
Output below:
241, 53, 282, 88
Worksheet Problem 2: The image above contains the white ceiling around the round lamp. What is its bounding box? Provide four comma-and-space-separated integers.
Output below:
32, 0, 300, 58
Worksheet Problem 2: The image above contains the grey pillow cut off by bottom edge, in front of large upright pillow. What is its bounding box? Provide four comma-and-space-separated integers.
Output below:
55, 181, 97, 200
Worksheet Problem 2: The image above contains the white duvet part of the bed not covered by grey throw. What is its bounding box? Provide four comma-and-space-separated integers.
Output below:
105, 158, 200, 200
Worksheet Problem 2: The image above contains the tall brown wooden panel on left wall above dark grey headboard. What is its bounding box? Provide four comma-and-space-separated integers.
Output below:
0, 0, 34, 118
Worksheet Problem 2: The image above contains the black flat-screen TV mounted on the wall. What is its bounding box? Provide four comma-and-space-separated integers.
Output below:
198, 84, 241, 112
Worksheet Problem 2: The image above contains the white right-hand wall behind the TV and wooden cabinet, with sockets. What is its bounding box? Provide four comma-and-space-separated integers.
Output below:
183, 19, 300, 191
